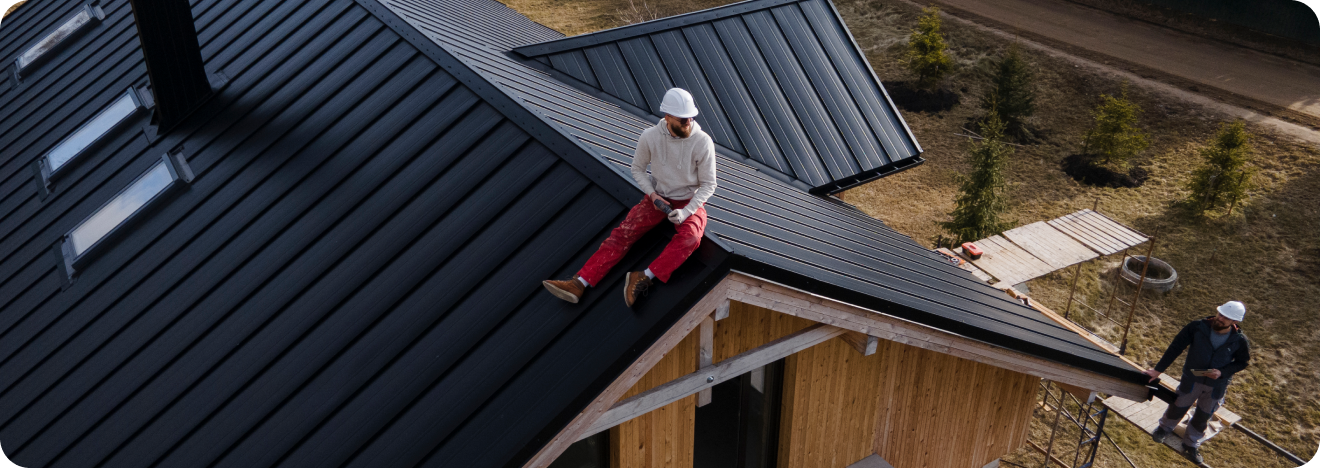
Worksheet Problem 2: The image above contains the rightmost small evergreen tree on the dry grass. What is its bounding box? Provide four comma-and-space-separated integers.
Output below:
1187, 120, 1254, 214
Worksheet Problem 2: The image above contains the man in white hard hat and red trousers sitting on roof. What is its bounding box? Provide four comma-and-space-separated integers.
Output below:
541, 88, 715, 307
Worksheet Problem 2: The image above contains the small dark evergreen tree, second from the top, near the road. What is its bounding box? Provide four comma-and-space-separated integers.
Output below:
981, 44, 1036, 137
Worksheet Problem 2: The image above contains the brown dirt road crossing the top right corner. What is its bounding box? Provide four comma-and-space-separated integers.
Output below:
936, 0, 1320, 128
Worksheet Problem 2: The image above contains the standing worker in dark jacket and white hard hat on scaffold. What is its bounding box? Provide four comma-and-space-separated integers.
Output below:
1146, 301, 1251, 464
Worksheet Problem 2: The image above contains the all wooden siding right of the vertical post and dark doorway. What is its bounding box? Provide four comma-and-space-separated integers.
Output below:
714, 302, 1038, 468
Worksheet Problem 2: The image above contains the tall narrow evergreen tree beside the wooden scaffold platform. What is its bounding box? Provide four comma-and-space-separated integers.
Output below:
940, 105, 1012, 244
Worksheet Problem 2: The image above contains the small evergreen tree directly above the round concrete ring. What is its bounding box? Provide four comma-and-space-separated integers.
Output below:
1082, 83, 1150, 166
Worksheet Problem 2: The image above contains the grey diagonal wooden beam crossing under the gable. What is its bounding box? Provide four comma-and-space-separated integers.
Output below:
578, 323, 845, 439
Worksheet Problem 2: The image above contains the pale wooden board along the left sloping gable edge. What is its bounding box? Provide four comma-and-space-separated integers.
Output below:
523, 277, 730, 468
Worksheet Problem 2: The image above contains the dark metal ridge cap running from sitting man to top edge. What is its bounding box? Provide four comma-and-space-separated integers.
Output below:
354, 0, 640, 206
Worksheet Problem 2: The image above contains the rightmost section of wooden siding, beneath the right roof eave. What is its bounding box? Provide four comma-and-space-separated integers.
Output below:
873, 341, 1038, 468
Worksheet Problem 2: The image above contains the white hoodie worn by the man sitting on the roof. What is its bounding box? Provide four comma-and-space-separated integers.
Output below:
632, 119, 715, 223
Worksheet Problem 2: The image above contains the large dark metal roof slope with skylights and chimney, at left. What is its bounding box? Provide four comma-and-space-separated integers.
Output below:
0, 0, 727, 468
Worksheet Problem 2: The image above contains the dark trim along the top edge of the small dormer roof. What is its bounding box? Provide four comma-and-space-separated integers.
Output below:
513, 0, 797, 57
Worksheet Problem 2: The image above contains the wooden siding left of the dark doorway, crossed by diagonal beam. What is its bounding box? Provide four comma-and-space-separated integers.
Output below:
610, 331, 698, 468
